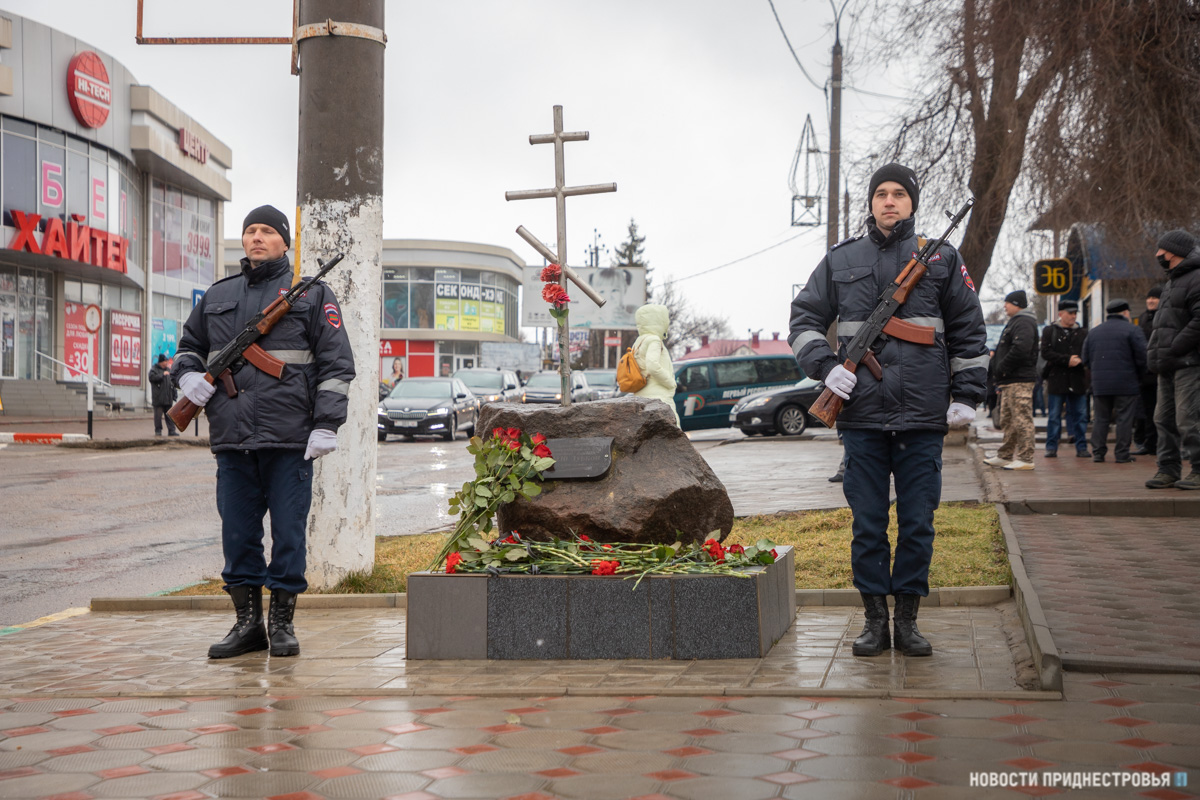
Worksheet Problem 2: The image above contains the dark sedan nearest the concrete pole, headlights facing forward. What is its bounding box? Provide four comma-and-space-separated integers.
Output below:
379, 378, 479, 441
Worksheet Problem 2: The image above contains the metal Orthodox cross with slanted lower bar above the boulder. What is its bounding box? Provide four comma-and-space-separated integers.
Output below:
504, 106, 617, 405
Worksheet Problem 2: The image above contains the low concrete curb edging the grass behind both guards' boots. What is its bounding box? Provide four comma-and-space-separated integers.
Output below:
90, 587, 1013, 613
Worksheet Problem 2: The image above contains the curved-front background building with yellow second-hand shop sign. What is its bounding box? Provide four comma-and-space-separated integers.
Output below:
224, 239, 526, 380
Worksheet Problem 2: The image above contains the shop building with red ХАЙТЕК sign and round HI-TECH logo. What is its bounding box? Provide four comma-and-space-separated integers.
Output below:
0, 12, 233, 405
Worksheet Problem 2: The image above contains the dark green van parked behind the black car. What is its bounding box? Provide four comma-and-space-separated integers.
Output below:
674, 355, 804, 431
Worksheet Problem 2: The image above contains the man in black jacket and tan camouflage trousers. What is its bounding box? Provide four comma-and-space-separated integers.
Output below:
984, 291, 1038, 470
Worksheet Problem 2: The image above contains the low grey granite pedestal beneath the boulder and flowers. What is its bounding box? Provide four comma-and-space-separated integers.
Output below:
407, 547, 796, 661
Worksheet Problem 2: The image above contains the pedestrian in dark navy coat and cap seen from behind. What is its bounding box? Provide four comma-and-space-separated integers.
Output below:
1084, 300, 1146, 464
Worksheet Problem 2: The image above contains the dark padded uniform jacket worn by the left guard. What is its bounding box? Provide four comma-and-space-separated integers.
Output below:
172, 255, 354, 452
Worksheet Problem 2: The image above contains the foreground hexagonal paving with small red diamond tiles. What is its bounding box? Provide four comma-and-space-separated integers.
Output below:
0, 675, 1200, 800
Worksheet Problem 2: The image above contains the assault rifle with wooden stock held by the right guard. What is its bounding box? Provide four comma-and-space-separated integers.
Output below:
809, 198, 974, 428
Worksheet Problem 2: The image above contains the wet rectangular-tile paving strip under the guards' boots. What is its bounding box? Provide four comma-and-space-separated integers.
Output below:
0, 603, 1021, 696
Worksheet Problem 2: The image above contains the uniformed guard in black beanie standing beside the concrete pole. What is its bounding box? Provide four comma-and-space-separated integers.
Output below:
174, 205, 354, 658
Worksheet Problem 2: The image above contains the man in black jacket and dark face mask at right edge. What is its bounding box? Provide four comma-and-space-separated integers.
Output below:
1146, 225, 1200, 489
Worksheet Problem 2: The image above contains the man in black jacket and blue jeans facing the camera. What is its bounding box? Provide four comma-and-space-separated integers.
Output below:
1042, 300, 1087, 458
